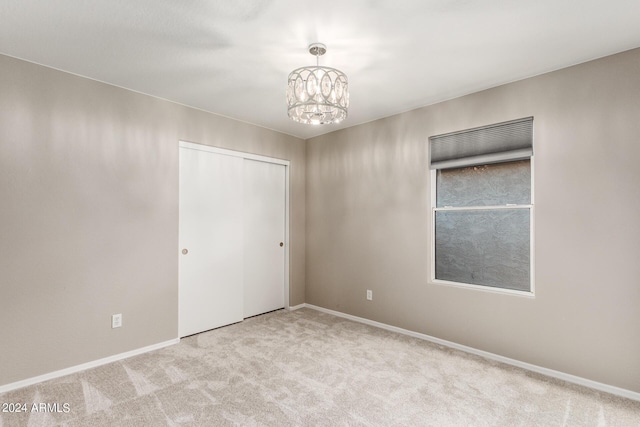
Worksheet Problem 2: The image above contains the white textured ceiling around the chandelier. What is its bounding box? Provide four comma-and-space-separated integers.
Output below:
0, 0, 640, 138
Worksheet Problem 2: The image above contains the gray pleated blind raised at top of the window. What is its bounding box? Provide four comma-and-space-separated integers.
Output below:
429, 117, 533, 169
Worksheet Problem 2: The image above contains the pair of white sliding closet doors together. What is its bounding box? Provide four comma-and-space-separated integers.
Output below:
179, 142, 288, 337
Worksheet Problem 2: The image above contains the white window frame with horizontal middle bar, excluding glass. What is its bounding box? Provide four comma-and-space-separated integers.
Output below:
429, 156, 535, 298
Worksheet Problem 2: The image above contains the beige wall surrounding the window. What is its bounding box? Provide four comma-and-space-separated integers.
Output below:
306, 50, 640, 392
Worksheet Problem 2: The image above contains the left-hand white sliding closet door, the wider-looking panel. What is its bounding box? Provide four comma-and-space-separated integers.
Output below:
179, 147, 244, 337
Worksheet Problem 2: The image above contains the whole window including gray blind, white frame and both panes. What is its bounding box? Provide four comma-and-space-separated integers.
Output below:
429, 118, 533, 295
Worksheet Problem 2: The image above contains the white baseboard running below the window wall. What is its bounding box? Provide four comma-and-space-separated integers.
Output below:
296, 304, 640, 401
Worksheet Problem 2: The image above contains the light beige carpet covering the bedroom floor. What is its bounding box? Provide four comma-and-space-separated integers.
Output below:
0, 309, 640, 427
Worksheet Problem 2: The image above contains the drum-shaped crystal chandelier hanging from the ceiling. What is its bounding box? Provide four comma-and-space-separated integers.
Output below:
287, 43, 349, 125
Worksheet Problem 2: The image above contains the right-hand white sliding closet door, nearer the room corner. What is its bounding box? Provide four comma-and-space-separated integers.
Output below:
244, 160, 285, 317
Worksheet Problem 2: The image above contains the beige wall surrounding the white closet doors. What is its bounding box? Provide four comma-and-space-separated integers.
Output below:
0, 56, 305, 385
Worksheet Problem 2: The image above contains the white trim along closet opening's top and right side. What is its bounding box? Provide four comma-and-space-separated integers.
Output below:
178, 141, 290, 310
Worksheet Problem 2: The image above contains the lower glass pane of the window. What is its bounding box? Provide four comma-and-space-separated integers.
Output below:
435, 209, 530, 291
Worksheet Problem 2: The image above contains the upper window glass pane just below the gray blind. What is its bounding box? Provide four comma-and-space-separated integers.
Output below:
436, 160, 531, 208
